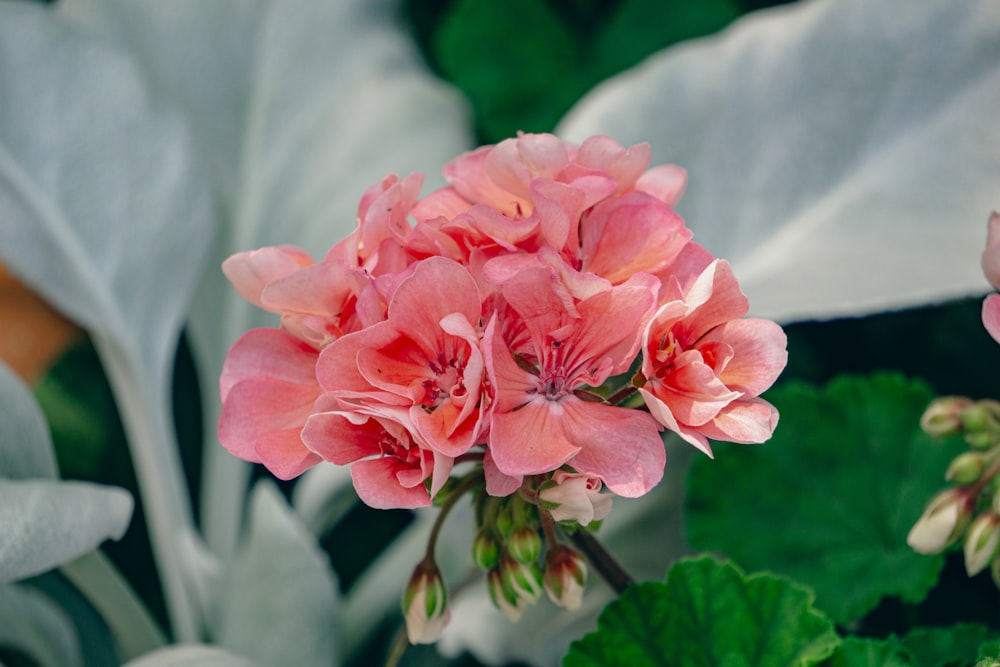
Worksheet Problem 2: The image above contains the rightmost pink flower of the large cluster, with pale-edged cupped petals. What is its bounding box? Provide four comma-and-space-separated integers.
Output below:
639, 260, 788, 456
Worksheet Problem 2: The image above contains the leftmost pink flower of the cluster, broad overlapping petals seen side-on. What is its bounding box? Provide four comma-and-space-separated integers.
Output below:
218, 329, 321, 479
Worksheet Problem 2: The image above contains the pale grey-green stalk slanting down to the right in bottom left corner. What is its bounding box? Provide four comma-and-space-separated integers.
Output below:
59, 550, 167, 661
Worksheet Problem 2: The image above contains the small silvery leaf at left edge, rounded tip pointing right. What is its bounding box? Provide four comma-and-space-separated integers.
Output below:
0, 479, 133, 583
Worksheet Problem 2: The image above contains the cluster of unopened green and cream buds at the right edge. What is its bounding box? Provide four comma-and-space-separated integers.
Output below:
906, 396, 1000, 586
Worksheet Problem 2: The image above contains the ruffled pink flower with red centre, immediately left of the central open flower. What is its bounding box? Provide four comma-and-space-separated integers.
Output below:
317, 257, 486, 456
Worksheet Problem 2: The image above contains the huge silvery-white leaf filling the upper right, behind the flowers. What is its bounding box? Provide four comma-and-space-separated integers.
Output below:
557, 0, 1000, 321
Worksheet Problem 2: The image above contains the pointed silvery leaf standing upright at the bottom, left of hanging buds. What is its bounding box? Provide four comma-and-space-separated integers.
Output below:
215, 481, 339, 665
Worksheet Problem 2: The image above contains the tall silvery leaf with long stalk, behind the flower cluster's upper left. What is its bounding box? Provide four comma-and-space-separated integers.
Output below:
60, 0, 471, 555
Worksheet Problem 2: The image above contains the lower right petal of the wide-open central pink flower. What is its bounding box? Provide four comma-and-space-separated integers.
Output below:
560, 398, 666, 498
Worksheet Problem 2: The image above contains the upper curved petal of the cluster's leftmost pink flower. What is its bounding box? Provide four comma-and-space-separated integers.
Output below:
219, 329, 319, 402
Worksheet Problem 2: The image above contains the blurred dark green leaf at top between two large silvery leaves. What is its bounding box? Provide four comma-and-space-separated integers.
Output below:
431, 0, 739, 143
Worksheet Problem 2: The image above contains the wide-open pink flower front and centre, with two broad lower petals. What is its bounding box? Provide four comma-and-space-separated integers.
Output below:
483, 266, 665, 497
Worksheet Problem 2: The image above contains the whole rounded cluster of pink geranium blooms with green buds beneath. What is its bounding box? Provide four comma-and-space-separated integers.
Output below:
219, 134, 786, 640
